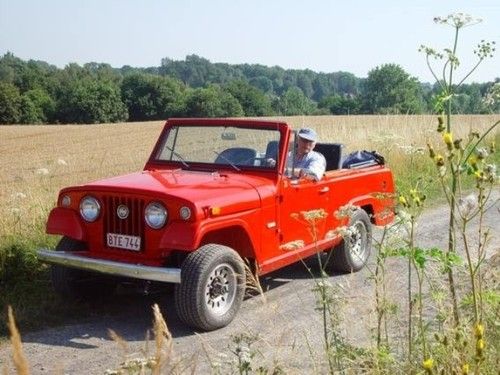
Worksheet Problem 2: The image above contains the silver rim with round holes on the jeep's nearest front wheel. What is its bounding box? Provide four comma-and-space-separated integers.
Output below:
205, 263, 238, 315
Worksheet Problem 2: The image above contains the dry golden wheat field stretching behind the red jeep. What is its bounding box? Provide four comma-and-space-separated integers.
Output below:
0, 115, 498, 242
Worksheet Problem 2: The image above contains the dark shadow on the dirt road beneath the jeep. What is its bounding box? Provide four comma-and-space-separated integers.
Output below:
15, 251, 344, 350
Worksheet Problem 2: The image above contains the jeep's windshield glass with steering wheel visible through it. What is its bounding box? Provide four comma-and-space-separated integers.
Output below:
155, 125, 280, 170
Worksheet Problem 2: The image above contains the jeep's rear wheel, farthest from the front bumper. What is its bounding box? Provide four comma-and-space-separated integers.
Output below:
330, 209, 372, 273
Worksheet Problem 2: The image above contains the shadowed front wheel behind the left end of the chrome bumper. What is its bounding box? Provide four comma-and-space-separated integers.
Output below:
51, 237, 116, 299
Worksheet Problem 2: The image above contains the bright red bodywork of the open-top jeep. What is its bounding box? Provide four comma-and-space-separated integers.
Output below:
47, 119, 394, 274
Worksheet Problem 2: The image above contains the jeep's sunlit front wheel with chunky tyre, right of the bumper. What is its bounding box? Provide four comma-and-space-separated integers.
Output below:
175, 244, 245, 331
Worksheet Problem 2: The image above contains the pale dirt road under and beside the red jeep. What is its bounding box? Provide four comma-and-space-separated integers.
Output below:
0, 192, 500, 374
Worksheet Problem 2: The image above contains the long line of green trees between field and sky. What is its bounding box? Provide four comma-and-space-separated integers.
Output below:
0, 53, 500, 124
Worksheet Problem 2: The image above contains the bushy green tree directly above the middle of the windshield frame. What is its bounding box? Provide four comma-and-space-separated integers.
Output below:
186, 85, 244, 117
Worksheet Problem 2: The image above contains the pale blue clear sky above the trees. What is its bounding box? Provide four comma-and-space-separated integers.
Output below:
0, 0, 500, 83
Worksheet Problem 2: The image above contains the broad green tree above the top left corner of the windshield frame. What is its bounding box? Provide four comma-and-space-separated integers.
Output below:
121, 73, 185, 121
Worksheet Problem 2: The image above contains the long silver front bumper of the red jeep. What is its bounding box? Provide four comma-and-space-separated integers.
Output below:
37, 249, 181, 284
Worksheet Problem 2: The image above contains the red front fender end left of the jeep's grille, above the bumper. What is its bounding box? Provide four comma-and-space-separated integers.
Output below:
45, 207, 87, 241
